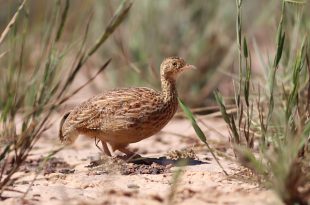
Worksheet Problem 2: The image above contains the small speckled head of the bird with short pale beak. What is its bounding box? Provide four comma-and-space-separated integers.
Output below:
160, 57, 196, 80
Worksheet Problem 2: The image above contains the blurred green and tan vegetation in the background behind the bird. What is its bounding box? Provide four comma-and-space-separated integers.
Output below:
0, 0, 310, 107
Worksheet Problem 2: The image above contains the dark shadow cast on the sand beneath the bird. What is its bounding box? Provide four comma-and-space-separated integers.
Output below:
128, 157, 209, 166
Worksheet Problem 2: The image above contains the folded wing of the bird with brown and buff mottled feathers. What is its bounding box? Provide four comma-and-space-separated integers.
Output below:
69, 88, 160, 132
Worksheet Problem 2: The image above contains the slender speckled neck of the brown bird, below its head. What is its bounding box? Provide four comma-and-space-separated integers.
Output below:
161, 76, 178, 102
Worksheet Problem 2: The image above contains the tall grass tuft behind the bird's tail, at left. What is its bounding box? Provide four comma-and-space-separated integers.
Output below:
0, 0, 132, 197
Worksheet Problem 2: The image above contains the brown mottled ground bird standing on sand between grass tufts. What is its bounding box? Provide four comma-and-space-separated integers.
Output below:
59, 57, 196, 157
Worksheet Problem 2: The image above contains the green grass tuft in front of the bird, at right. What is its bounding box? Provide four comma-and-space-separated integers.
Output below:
214, 0, 310, 205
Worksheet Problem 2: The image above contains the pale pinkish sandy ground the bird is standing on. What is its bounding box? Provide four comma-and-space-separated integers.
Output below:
1, 116, 281, 205
